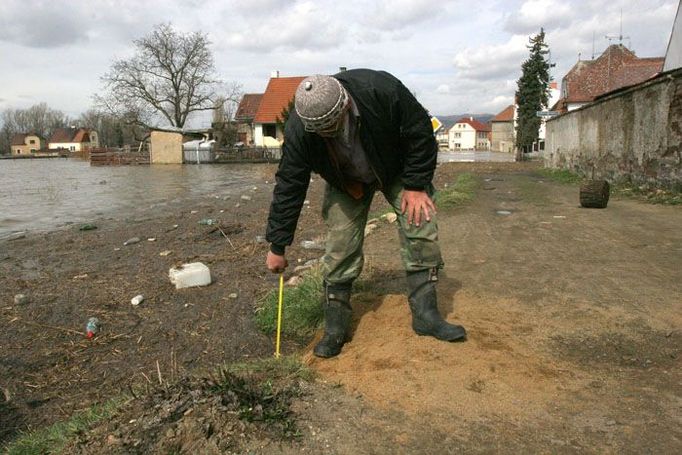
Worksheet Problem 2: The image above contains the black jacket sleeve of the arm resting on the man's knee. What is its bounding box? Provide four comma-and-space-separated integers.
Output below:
398, 83, 438, 190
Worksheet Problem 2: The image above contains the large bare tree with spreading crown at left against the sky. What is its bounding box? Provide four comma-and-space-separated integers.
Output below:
95, 24, 218, 128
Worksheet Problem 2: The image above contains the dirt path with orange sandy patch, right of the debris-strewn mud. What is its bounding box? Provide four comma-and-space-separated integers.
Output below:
308, 166, 682, 453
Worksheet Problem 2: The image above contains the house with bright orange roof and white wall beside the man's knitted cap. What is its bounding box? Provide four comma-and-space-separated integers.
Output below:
253, 71, 305, 147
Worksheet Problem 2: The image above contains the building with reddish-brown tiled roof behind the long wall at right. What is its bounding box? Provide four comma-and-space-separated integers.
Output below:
551, 44, 664, 113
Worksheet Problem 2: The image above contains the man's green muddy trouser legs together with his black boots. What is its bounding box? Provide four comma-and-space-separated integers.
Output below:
314, 179, 466, 357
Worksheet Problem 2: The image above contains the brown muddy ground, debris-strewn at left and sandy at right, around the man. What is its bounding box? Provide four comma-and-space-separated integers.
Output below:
0, 163, 682, 454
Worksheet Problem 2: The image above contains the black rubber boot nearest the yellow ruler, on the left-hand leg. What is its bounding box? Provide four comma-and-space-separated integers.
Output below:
313, 283, 353, 358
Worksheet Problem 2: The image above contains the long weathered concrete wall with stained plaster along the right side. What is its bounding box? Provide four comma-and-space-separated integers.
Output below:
544, 70, 682, 187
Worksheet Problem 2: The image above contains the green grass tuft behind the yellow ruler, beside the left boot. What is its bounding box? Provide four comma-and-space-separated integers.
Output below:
255, 267, 324, 342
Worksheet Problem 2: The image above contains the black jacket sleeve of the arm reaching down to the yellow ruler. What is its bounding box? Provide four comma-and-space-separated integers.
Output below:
265, 135, 310, 255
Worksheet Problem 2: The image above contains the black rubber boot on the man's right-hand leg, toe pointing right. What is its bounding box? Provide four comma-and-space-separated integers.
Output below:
407, 269, 466, 341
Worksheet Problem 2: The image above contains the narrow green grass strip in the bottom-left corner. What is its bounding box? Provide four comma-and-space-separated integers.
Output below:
3, 396, 128, 455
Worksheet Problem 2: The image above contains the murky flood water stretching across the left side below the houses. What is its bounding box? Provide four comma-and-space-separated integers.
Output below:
0, 158, 262, 238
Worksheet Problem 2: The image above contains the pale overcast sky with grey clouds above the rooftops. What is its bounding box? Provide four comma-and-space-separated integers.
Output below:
0, 0, 678, 123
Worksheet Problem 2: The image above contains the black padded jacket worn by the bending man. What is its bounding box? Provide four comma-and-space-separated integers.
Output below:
266, 69, 438, 254
